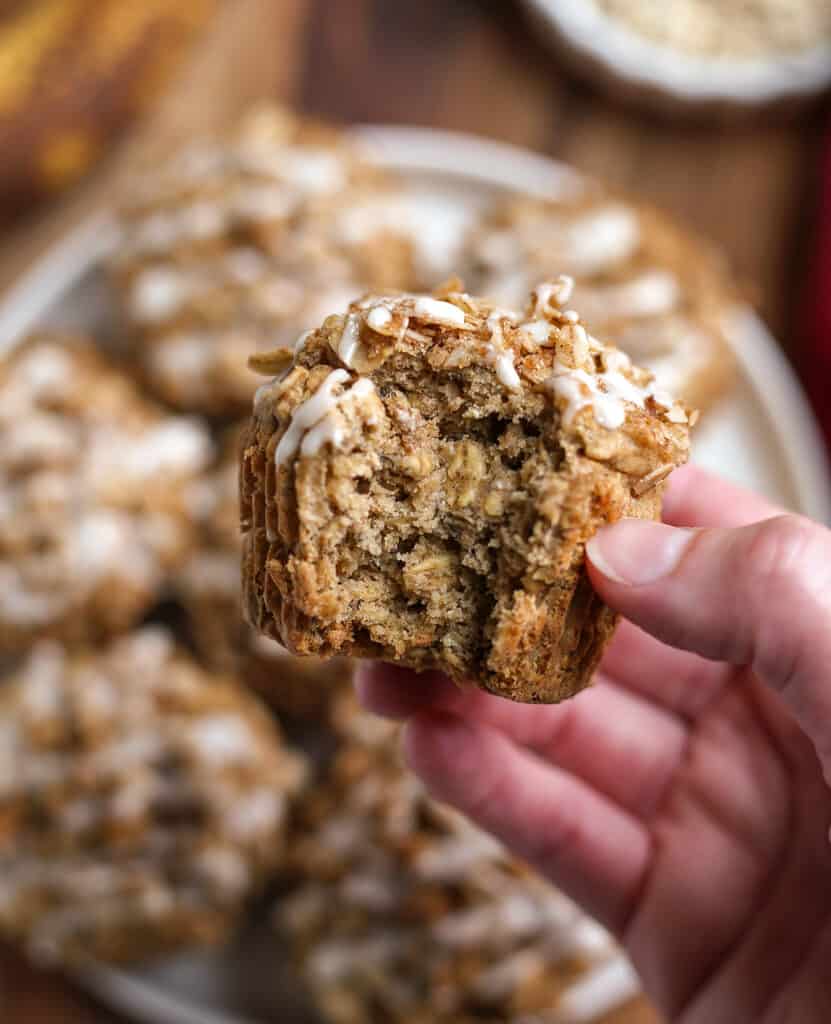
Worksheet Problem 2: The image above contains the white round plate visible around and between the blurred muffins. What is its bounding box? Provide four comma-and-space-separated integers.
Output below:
0, 128, 831, 1024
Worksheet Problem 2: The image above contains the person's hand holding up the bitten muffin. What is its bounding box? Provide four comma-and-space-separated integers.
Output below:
357, 467, 831, 1024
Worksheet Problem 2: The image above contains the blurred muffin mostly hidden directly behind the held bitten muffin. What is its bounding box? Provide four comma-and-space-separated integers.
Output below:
182, 430, 352, 718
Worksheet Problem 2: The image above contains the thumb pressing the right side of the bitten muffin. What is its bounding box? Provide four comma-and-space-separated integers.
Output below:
586, 516, 831, 774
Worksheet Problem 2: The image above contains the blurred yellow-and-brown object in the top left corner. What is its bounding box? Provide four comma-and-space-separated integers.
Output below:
0, 0, 217, 219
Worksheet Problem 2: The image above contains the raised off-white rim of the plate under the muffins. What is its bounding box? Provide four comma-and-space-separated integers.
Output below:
0, 125, 831, 1024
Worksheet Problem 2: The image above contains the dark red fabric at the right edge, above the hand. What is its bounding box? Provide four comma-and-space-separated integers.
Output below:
799, 135, 831, 450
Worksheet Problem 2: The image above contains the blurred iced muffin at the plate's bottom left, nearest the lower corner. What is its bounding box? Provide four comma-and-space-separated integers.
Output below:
0, 628, 304, 963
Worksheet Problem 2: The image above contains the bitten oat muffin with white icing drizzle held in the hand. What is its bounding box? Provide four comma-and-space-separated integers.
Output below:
242, 279, 690, 701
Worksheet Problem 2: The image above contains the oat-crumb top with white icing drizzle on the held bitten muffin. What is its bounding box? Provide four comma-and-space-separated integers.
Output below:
252, 276, 689, 485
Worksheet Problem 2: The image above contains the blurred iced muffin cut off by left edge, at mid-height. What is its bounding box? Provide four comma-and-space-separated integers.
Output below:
0, 335, 212, 652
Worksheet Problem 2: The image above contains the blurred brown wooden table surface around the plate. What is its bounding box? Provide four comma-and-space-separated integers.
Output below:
0, 0, 825, 1024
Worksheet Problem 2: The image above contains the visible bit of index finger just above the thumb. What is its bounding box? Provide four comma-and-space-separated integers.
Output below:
663, 466, 786, 527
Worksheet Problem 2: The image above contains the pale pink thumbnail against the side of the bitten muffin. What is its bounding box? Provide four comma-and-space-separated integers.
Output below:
585, 519, 696, 587
